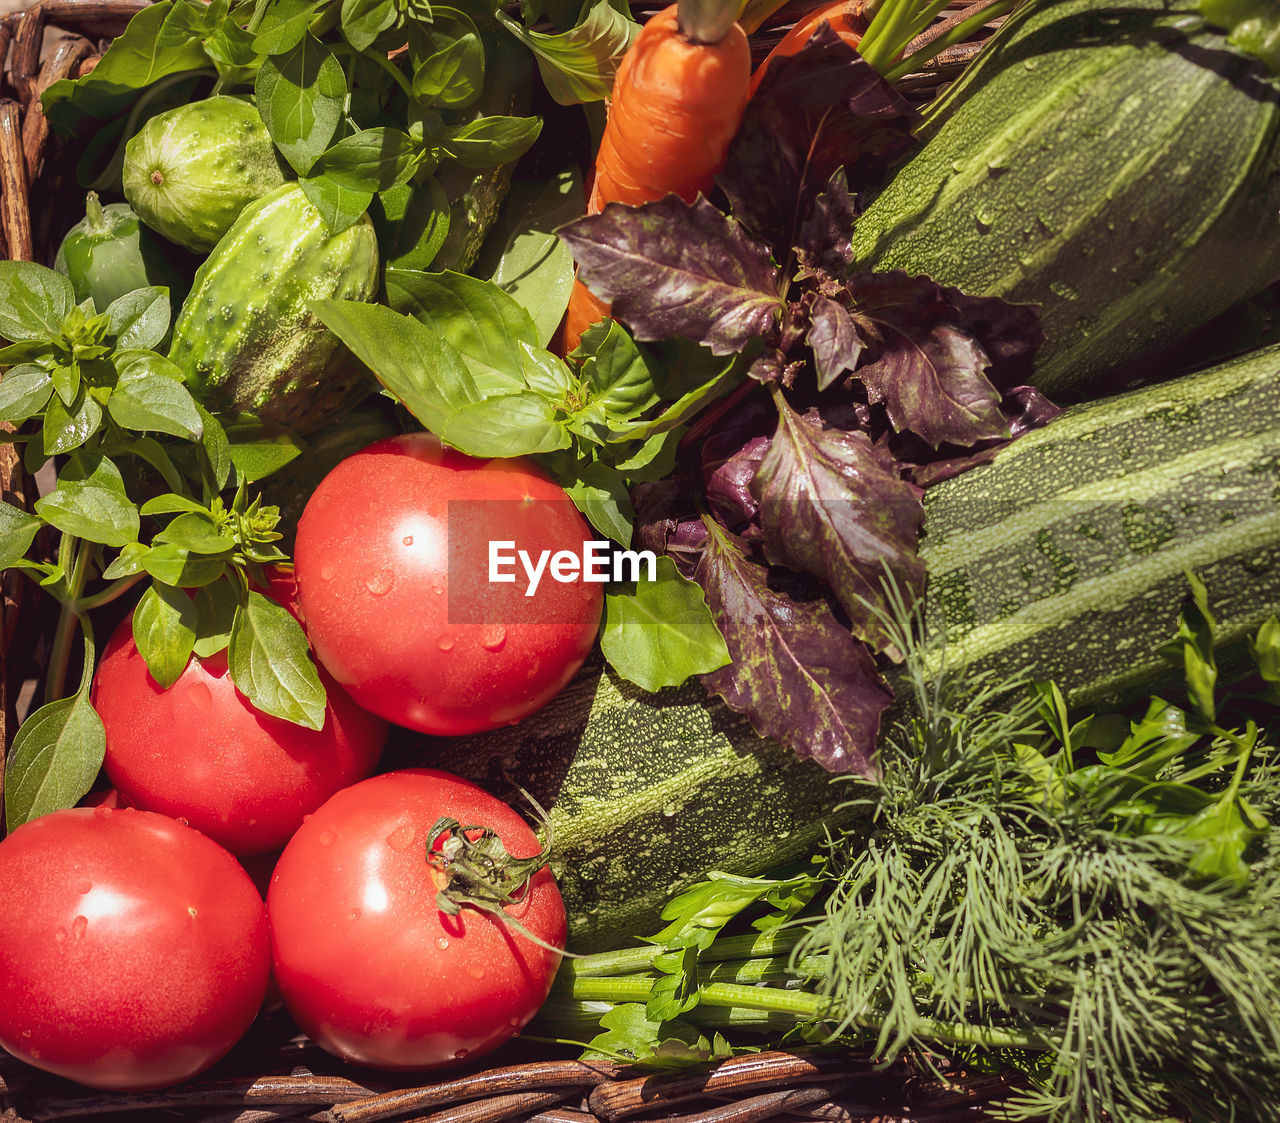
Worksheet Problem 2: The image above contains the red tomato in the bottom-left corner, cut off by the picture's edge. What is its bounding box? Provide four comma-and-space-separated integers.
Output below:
0, 807, 271, 1090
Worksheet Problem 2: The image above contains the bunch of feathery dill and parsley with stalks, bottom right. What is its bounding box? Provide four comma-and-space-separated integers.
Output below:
544, 579, 1280, 1123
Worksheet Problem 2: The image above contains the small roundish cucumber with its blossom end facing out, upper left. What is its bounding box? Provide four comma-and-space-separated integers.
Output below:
122, 96, 284, 252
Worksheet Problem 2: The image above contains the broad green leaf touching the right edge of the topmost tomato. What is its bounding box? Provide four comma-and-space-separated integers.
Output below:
600, 556, 730, 693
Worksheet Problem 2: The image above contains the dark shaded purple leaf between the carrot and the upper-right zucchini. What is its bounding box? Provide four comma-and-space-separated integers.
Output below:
717, 27, 919, 254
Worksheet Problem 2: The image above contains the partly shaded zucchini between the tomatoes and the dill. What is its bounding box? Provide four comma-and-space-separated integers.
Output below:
414, 659, 849, 951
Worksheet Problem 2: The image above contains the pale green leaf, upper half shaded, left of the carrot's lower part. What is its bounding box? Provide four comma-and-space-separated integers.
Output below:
475, 169, 586, 347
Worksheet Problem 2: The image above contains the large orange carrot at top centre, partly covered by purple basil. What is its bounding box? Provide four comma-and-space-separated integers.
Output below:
558, 0, 751, 355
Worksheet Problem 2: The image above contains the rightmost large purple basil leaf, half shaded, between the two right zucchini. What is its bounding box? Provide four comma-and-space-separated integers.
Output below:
849, 270, 1009, 448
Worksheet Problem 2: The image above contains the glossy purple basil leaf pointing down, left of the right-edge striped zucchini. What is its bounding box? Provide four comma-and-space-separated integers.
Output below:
751, 400, 924, 650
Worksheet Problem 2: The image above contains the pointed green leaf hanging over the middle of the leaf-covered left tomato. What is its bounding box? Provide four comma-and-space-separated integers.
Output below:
227, 590, 325, 729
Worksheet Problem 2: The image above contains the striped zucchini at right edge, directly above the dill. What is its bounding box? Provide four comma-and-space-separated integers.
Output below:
920, 347, 1280, 704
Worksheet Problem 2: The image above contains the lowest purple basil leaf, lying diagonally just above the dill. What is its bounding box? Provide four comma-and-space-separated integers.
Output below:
694, 525, 892, 776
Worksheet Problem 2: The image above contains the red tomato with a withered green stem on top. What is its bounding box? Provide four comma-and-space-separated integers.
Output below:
266, 768, 566, 1069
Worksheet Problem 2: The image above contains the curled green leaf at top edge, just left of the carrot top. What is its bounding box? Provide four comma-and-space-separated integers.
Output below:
498, 0, 640, 105
